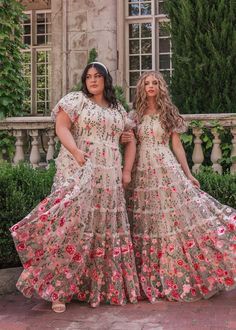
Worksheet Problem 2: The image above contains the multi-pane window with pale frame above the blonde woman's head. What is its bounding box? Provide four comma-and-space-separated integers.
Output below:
124, 0, 172, 102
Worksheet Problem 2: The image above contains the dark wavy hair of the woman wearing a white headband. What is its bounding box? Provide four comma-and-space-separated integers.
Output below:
81, 62, 118, 109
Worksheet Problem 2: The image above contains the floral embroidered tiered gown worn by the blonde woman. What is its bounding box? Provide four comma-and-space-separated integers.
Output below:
127, 114, 236, 302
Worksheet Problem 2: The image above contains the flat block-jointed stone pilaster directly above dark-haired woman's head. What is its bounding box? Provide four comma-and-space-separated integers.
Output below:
67, 0, 117, 89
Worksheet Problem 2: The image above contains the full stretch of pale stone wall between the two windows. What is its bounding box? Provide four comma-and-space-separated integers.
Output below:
52, 0, 117, 105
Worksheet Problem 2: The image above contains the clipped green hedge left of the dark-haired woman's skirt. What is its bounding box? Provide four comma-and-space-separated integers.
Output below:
0, 162, 55, 268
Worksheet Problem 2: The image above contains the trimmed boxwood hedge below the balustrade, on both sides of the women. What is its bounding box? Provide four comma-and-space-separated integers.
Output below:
0, 163, 236, 268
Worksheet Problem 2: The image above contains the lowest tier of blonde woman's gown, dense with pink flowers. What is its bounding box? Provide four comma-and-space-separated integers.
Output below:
133, 222, 236, 302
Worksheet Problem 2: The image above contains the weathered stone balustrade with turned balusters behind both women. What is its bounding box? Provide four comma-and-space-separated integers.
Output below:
0, 114, 236, 173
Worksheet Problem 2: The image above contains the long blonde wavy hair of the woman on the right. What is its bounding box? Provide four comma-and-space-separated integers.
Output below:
133, 71, 186, 134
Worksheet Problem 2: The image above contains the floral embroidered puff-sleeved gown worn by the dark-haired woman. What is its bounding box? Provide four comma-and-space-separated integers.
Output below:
11, 92, 139, 307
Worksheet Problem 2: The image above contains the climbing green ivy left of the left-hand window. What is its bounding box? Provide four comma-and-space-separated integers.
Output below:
0, 0, 24, 118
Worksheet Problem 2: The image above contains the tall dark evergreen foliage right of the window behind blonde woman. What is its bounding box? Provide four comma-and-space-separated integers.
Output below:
165, 0, 236, 113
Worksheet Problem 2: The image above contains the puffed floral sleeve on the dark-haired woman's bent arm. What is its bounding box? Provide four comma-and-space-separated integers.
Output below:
51, 92, 85, 123
